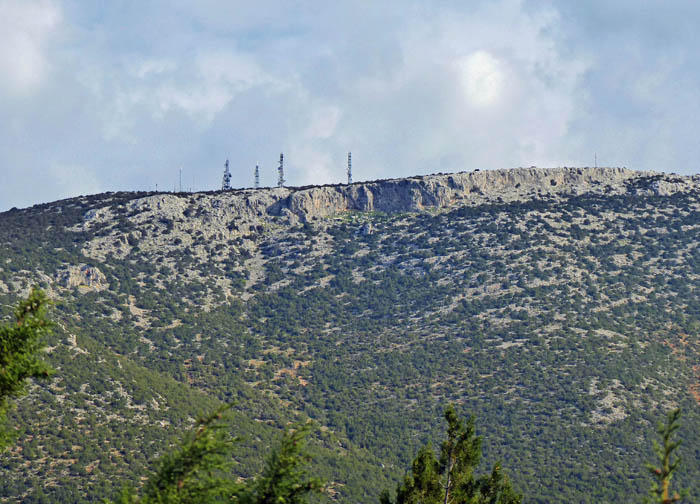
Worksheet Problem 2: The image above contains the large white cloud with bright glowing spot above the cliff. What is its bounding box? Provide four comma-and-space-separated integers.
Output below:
328, 0, 590, 176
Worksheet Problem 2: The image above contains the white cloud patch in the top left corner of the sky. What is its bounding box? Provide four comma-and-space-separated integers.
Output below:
0, 0, 62, 95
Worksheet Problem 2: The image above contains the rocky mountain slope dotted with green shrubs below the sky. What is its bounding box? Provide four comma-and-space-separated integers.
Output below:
0, 167, 700, 502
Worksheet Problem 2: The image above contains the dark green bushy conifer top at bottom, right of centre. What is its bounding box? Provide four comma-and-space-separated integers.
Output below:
380, 405, 522, 504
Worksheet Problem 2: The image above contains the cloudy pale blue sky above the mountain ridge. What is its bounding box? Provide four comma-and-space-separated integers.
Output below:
0, 0, 700, 211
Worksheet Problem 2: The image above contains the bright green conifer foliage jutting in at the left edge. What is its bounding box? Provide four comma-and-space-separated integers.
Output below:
0, 287, 53, 451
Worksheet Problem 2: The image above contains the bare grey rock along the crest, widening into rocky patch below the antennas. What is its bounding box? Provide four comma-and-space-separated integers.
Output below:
65, 167, 700, 282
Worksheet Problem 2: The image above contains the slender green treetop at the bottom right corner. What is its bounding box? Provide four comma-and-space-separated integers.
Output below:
647, 409, 681, 504
